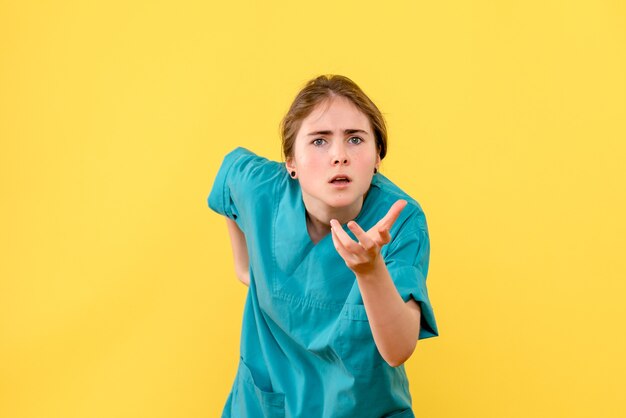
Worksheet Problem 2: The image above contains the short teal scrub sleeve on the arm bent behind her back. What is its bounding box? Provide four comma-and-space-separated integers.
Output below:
207, 147, 277, 232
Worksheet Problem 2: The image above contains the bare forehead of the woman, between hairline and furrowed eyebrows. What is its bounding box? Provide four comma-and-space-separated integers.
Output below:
302, 96, 370, 132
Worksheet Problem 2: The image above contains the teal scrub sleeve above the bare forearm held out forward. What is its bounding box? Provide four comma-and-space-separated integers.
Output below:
385, 228, 439, 340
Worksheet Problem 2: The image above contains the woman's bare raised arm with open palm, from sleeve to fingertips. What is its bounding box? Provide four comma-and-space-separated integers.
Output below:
331, 200, 421, 367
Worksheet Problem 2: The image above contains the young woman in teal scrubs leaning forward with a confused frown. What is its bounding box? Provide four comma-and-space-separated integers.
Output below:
208, 75, 438, 418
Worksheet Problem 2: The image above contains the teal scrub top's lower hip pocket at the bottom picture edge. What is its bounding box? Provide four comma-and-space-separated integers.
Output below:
232, 358, 285, 418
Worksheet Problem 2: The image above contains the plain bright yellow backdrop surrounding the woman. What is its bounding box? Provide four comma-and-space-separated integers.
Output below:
0, 0, 626, 418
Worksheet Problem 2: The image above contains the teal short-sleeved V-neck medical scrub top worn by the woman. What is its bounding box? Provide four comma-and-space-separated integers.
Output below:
208, 147, 438, 418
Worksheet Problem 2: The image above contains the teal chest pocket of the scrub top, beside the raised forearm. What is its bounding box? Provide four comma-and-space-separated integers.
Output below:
339, 303, 385, 376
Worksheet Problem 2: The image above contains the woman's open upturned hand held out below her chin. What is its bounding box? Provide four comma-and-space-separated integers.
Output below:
330, 199, 407, 274
